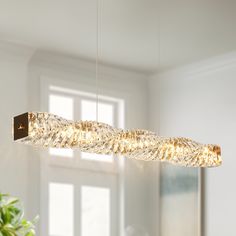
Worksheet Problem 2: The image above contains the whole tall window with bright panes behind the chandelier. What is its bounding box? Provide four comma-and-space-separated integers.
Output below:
41, 77, 123, 236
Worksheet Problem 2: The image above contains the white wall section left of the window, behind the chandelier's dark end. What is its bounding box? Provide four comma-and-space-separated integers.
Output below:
0, 42, 32, 215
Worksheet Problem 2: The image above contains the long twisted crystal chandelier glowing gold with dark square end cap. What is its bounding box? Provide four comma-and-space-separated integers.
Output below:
13, 112, 222, 167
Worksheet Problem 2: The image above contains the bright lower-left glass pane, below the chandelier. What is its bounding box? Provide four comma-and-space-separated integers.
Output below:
49, 183, 74, 236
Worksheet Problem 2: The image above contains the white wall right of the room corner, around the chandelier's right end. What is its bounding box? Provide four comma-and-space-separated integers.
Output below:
149, 53, 236, 236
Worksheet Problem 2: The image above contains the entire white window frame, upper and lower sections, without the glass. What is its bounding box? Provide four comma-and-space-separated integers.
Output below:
40, 76, 124, 236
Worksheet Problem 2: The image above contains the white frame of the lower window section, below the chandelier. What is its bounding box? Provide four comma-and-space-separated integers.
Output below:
40, 167, 120, 236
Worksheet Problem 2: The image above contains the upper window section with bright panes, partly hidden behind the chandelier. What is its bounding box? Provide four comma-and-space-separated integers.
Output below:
47, 86, 120, 168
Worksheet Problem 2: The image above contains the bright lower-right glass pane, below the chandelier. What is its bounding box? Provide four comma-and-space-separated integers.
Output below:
81, 186, 110, 236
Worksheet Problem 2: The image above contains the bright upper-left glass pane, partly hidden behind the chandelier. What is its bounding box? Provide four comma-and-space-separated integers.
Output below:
49, 94, 74, 157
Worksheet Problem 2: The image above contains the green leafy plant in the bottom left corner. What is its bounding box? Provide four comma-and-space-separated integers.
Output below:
0, 193, 37, 236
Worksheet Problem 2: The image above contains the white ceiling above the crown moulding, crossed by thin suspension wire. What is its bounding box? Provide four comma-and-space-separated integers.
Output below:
0, 0, 236, 72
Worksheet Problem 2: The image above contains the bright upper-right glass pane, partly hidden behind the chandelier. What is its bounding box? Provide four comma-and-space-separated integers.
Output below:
81, 100, 114, 162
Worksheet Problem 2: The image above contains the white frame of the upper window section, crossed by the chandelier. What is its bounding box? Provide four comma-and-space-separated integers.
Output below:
41, 77, 124, 174
